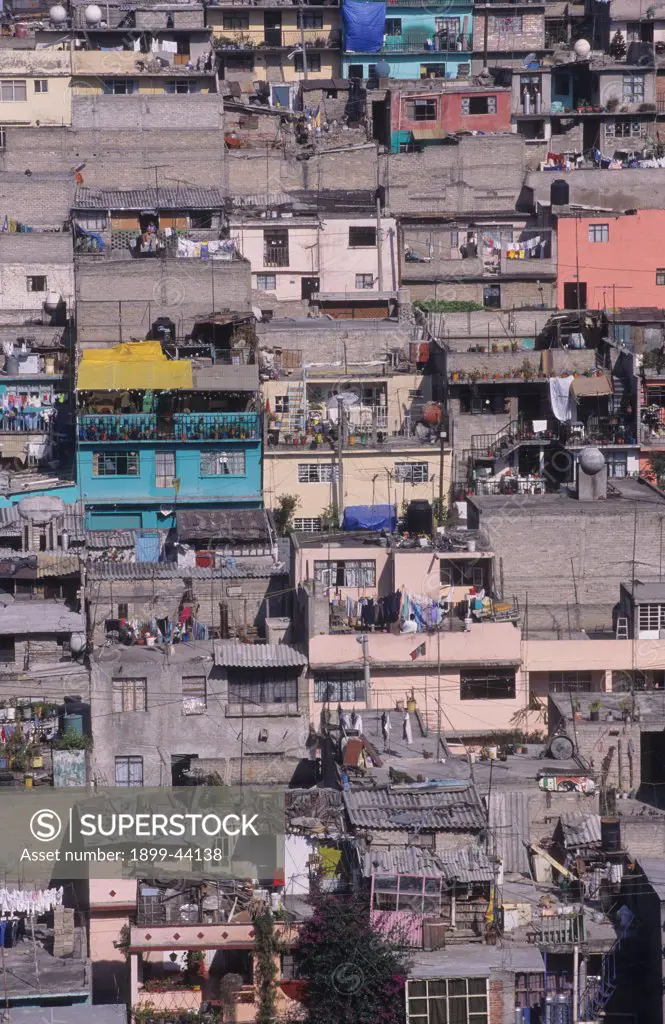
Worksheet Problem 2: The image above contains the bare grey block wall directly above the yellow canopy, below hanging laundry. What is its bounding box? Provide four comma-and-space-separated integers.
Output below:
76, 256, 251, 344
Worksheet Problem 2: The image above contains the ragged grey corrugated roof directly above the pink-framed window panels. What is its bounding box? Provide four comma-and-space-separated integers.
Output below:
365, 846, 494, 882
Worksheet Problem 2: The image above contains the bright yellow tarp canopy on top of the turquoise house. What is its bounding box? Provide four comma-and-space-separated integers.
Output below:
78, 341, 194, 391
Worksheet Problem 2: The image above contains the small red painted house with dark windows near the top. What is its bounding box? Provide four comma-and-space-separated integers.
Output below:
389, 83, 510, 153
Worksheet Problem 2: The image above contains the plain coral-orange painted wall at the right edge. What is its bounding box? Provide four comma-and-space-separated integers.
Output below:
556, 211, 665, 309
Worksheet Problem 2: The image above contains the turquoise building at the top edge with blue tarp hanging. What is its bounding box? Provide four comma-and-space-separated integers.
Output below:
342, 0, 473, 80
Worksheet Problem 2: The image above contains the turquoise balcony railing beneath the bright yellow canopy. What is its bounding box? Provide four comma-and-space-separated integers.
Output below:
79, 413, 260, 443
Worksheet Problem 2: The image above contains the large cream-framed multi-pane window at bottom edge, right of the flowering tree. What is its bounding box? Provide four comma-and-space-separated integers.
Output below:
407, 978, 490, 1024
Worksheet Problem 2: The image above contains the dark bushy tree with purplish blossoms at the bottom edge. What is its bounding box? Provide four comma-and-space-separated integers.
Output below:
293, 894, 408, 1024
